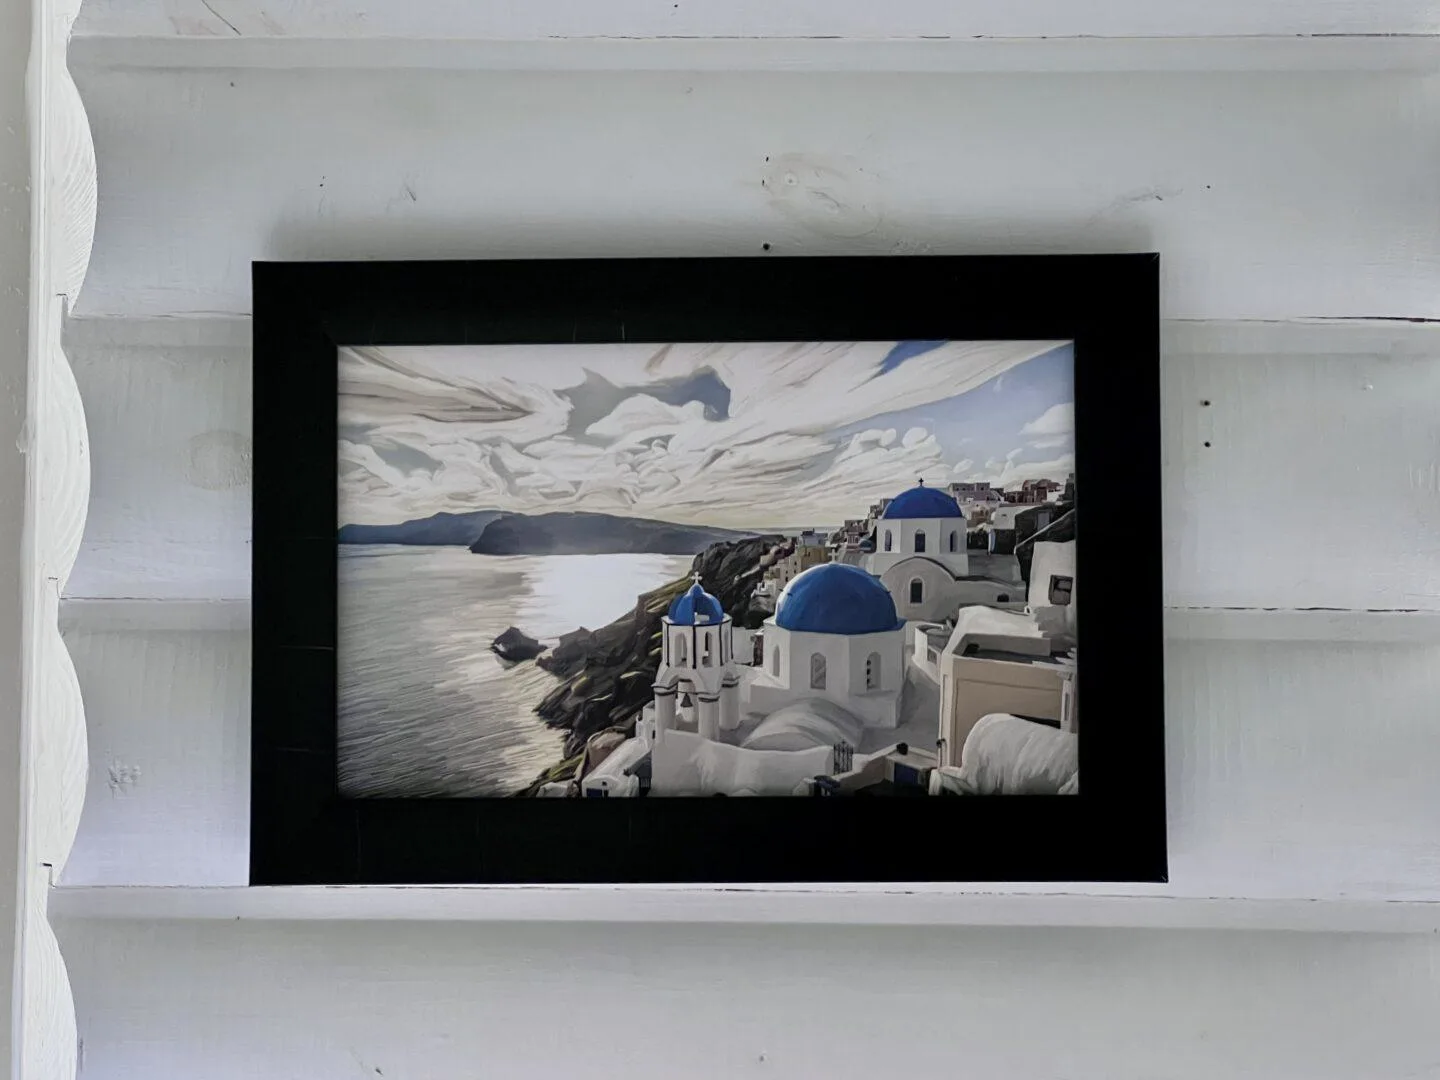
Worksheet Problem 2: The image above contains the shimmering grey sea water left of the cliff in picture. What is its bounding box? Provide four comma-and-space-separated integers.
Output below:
337, 544, 691, 798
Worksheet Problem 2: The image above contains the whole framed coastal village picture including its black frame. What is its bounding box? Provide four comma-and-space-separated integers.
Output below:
251, 255, 1166, 884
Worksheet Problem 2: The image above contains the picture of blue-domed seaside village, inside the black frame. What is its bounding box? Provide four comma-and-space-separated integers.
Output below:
337, 341, 1080, 799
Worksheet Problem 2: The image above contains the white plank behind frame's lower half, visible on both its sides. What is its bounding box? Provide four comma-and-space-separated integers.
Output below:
62, 631, 1440, 900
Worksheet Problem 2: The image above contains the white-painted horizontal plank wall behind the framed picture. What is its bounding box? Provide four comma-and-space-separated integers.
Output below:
33, 0, 1440, 1080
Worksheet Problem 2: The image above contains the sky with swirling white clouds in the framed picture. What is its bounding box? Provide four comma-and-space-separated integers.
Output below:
338, 341, 1074, 527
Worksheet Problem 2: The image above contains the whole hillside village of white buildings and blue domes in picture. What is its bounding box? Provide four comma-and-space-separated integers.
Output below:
531, 474, 1079, 798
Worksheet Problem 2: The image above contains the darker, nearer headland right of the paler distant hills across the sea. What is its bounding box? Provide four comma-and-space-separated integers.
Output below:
469, 513, 749, 554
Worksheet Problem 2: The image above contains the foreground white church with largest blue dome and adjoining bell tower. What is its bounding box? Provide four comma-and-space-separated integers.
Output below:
582, 563, 904, 796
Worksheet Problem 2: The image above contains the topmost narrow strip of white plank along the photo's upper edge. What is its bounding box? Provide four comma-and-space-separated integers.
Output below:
76, 0, 1440, 39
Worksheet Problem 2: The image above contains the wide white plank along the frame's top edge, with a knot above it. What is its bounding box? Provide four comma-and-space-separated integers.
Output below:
67, 68, 1440, 320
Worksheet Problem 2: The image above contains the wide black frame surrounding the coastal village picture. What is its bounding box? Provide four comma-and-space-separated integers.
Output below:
251, 253, 1166, 886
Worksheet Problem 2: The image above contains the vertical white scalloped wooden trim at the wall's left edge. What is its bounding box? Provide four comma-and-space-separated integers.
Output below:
17, 0, 96, 1080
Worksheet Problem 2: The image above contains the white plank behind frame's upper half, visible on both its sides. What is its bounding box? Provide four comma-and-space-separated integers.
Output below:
68, 318, 1440, 613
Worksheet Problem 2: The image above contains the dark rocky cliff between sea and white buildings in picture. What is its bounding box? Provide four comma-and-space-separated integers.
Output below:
536, 536, 783, 772
